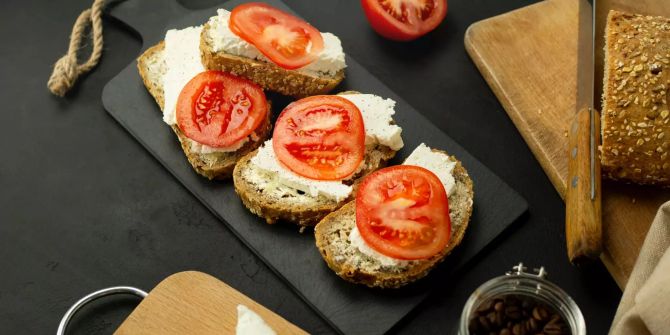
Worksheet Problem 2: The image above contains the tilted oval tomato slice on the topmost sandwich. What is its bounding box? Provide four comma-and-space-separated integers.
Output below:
228, 2, 323, 70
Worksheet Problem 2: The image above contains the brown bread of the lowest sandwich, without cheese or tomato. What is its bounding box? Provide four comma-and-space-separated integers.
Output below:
314, 149, 474, 288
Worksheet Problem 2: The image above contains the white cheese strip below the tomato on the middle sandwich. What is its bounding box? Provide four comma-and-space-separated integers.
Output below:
251, 139, 352, 202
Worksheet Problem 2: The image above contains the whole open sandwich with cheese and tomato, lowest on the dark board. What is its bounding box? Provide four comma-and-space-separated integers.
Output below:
314, 144, 474, 288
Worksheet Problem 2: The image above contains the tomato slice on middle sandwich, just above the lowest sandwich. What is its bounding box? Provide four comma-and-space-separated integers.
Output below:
272, 95, 365, 180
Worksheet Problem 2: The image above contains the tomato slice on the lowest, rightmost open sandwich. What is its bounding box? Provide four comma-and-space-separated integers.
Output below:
356, 165, 451, 260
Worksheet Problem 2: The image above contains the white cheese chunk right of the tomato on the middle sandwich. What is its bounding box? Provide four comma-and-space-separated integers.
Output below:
339, 94, 404, 151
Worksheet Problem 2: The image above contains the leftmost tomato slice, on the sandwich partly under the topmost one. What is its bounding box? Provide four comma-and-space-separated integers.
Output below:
176, 71, 268, 147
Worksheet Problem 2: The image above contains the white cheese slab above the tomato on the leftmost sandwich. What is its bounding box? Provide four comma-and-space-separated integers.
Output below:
163, 26, 205, 125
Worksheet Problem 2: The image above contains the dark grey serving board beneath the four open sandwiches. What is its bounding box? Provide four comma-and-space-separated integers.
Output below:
102, 0, 527, 334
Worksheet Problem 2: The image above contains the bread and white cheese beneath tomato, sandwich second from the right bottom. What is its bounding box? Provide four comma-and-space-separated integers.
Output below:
233, 92, 403, 226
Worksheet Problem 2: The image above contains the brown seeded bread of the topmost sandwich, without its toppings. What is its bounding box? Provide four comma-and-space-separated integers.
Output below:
200, 23, 344, 98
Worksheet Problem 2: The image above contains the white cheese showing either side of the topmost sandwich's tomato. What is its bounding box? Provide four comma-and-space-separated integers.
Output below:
208, 9, 347, 76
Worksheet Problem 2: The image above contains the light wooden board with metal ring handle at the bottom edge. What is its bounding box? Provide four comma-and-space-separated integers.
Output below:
114, 271, 307, 335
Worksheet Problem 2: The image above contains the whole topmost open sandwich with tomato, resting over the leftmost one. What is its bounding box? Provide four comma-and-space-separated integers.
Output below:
200, 3, 346, 97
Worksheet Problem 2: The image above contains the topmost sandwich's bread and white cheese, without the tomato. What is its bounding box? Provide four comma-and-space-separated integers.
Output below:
200, 9, 346, 97
